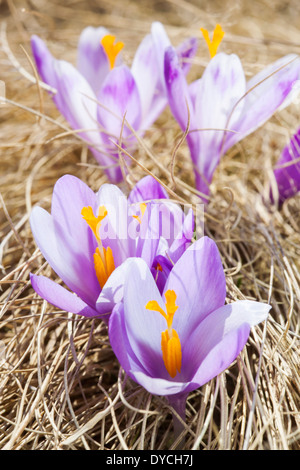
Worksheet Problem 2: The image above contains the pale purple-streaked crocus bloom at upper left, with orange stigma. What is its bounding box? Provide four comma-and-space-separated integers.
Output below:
31, 22, 196, 182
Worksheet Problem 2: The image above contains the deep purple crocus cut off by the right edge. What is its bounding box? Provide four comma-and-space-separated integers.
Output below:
271, 129, 300, 204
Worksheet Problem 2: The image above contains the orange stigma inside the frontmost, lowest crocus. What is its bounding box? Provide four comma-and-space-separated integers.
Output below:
146, 290, 182, 379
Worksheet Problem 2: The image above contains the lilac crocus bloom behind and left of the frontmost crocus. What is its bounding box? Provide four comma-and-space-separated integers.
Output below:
30, 175, 192, 317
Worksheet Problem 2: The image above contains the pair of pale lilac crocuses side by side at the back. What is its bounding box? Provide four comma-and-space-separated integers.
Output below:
31, 22, 300, 200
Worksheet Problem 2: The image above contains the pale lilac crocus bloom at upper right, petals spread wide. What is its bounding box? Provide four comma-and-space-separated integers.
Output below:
165, 47, 300, 195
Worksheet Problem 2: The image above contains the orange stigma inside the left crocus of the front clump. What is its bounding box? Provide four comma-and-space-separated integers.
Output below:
81, 206, 115, 289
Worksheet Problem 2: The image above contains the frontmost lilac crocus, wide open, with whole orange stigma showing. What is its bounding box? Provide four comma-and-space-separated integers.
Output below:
109, 237, 270, 436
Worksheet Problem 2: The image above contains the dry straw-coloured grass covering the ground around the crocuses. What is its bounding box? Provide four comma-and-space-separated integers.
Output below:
0, 0, 300, 450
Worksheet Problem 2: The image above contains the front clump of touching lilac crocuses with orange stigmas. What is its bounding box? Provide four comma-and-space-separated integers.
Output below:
30, 175, 270, 436
